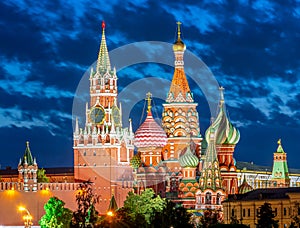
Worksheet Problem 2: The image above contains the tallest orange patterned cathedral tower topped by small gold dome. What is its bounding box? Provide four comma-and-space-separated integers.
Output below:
162, 22, 202, 171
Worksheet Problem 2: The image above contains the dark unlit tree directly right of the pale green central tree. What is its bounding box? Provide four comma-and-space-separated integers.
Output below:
151, 200, 194, 228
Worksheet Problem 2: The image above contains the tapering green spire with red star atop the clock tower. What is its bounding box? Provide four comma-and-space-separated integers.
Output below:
97, 21, 111, 71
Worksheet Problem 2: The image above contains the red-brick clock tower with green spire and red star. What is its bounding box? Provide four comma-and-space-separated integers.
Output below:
73, 22, 134, 214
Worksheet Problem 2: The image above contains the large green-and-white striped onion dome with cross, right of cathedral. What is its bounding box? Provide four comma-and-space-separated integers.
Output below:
205, 87, 240, 145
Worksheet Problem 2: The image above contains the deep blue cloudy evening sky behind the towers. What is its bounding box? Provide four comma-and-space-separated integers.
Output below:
0, 0, 300, 167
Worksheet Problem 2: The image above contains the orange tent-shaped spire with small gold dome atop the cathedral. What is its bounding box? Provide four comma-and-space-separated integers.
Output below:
166, 22, 194, 102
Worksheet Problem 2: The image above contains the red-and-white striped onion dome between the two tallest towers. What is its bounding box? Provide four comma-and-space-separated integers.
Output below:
134, 111, 167, 148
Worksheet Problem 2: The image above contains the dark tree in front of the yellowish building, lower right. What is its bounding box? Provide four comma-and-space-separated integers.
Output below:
256, 202, 278, 228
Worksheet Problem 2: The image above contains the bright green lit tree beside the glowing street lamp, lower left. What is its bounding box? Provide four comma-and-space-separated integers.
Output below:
39, 197, 72, 228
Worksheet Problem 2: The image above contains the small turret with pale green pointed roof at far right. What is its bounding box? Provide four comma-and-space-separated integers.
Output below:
271, 139, 290, 187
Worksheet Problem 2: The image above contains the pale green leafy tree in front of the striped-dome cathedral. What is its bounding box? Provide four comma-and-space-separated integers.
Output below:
124, 188, 166, 227
